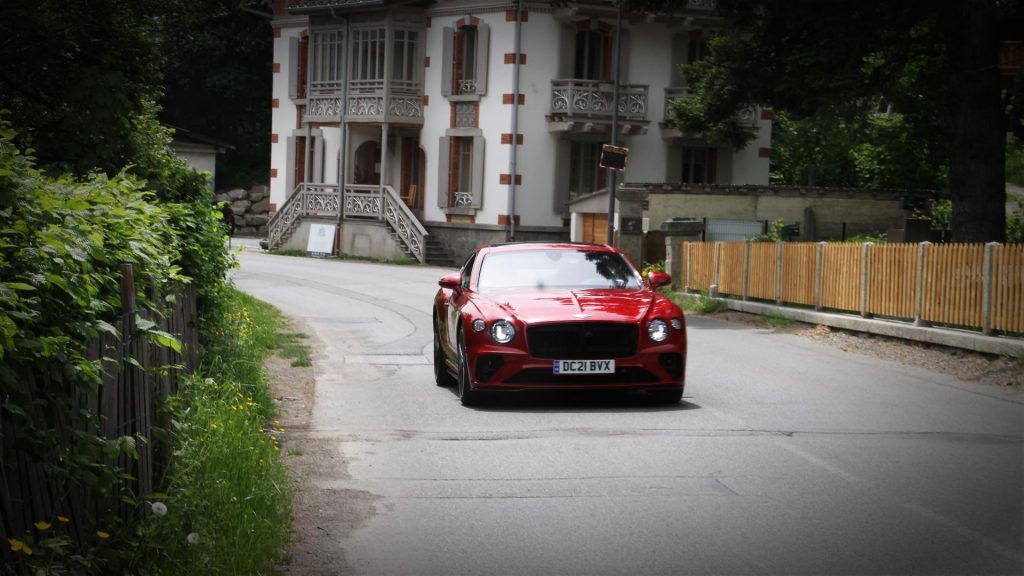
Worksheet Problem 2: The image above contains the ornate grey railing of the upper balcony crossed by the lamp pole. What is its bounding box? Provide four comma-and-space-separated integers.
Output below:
551, 79, 647, 122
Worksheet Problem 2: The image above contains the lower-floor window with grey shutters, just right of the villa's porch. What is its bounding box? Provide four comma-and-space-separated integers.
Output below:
437, 134, 483, 210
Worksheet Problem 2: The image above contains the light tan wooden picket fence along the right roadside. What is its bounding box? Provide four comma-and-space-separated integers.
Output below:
674, 242, 1024, 334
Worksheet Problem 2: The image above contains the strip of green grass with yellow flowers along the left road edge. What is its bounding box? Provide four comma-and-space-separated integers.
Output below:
138, 290, 294, 576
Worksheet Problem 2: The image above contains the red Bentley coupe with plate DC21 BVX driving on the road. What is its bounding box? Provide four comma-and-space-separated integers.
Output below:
433, 243, 686, 406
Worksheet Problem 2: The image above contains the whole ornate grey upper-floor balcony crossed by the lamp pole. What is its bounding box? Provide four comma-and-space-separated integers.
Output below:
548, 79, 649, 134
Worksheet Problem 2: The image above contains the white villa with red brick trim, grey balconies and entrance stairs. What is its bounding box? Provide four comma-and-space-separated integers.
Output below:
268, 0, 771, 263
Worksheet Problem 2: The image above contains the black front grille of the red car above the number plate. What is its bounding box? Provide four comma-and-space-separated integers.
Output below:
526, 322, 639, 360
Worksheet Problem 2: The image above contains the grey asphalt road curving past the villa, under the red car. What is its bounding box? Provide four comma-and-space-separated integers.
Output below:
233, 241, 1024, 575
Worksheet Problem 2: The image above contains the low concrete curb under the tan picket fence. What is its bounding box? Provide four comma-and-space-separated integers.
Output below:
718, 298, 1024, 358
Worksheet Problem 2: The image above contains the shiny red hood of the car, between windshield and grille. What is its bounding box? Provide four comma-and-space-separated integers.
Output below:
475, 289, 654, 324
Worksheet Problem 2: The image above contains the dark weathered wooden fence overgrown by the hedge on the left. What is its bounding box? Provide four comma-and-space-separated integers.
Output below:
0, 265, 199, 573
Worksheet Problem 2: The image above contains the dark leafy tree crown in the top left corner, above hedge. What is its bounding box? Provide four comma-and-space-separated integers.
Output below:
0, 0, 161, 175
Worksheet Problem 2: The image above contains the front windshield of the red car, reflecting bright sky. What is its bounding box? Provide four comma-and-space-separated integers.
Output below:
477, 249, 642, 292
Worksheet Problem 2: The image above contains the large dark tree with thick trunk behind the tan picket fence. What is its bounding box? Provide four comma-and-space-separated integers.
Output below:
624, 0, 1024, 242
